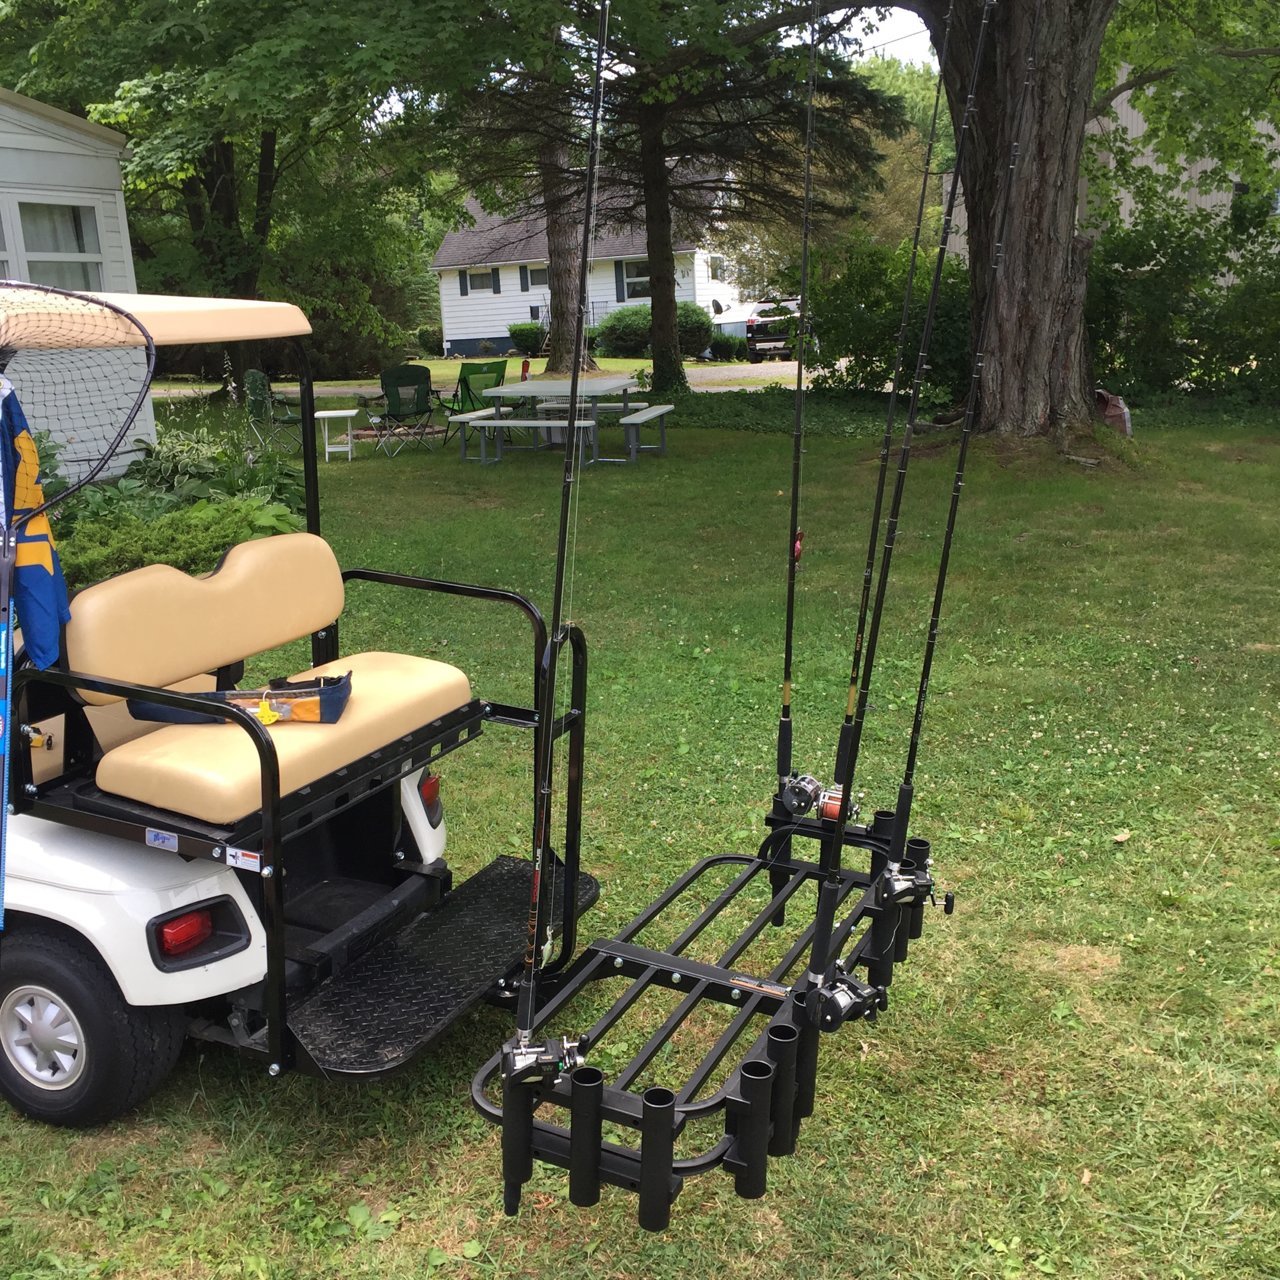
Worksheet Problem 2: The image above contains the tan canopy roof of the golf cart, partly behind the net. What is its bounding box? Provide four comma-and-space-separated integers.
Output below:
0, 284, 311, 349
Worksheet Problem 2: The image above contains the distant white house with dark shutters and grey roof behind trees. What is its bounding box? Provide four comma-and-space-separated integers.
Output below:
431, 202, 739, 356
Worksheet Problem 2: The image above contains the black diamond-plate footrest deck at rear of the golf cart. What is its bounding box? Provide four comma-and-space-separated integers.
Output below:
289, 858, 600, 1078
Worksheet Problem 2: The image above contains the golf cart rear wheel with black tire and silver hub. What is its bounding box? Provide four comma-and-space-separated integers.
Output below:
0, 928, 184, 1128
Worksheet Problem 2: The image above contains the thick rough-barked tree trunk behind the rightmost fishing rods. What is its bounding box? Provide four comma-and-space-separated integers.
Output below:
911, 0, 1116, 440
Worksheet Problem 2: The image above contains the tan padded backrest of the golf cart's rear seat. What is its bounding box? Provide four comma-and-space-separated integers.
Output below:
64, 534, 343, 705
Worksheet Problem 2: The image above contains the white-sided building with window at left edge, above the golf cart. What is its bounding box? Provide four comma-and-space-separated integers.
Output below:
0, 88, 155, 472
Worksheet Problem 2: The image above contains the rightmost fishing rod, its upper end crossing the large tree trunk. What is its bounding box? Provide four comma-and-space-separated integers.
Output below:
902, 9, 1042, 808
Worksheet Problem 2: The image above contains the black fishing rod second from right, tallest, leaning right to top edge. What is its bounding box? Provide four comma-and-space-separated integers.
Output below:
822, 0, 996, 869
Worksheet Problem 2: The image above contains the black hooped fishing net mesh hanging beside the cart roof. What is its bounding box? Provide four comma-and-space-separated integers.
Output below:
0, 283, 155, 518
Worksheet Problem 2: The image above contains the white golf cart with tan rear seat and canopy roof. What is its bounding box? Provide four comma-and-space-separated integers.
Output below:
0, 285, 596, 1125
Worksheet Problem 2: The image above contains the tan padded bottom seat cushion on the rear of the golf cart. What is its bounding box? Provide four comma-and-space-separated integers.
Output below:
97, 653, 471, 826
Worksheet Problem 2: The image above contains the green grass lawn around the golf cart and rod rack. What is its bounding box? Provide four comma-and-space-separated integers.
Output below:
0, 396, 1280, 1280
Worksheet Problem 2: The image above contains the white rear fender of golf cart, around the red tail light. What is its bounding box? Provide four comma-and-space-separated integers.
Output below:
4, 814, 266, 1005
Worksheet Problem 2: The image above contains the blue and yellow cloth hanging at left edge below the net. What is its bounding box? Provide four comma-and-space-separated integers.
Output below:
0, 375, 72, 671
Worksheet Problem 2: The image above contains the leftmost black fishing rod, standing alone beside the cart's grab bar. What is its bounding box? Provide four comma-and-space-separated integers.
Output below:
516, 0, 609, 1047
